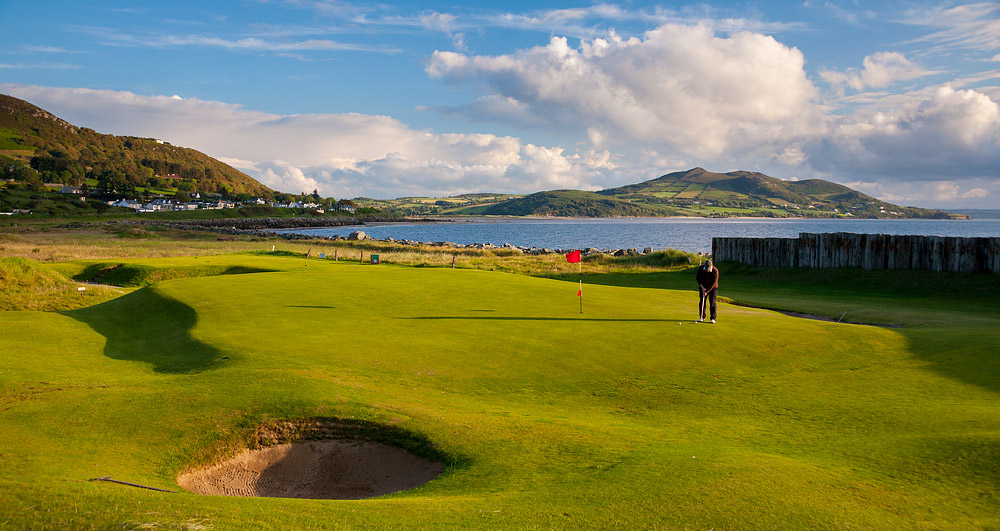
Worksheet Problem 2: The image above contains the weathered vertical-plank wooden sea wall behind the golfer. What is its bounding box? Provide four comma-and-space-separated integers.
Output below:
712, 232, 1000, 273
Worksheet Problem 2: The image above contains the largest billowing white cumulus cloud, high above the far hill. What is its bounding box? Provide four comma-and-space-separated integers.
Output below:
426, 24, 823, 158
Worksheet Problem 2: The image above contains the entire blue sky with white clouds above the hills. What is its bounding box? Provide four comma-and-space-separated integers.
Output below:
0, 0, 1000, 208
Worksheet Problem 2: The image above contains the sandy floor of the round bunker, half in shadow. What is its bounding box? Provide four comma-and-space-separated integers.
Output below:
177, 440, 444, 500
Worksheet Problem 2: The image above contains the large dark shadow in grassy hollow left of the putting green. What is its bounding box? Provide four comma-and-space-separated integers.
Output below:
61, 288, 222, 374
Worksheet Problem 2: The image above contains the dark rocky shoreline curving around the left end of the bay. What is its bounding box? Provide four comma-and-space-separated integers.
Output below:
110, 216, 653, 256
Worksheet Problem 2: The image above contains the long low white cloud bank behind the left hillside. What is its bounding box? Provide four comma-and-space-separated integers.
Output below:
0, 85, 615, 197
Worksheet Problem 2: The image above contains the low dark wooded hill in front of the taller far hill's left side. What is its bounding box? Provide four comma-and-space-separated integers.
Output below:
483, 190, 670, 218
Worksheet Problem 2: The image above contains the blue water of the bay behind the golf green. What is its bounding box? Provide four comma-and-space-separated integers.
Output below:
278, 218, 1000, 253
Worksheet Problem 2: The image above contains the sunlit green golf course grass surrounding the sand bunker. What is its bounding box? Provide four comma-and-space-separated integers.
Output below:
0, 224, 1000, 529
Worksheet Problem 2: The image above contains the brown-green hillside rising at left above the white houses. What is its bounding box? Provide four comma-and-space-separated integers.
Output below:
0, 94, 274, 198
